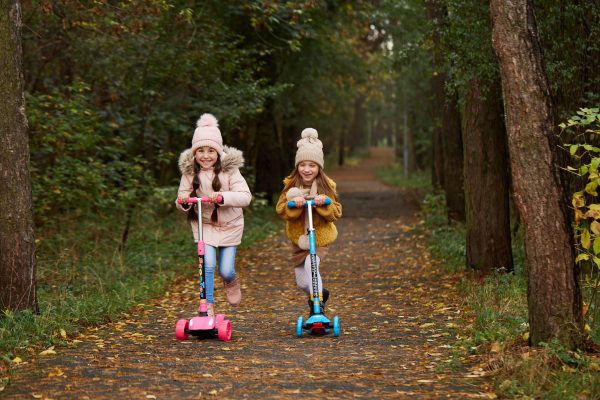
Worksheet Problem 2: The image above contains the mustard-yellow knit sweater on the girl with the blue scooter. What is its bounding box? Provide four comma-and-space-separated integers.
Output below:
276, 178, 342, 247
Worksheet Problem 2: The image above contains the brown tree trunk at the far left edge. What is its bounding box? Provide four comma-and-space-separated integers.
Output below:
0, 0, 37, 312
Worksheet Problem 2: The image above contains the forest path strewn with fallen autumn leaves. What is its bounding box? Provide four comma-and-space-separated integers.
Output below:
1, 149, 493, 399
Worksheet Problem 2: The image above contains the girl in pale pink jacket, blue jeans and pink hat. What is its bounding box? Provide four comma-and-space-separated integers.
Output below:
175, 114, 252, 315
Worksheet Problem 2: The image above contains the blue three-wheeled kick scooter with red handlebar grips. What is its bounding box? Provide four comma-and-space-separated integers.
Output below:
288, 198, 340, 337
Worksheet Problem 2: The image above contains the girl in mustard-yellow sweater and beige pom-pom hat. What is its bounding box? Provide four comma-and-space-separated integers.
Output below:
277, 128, 342, 315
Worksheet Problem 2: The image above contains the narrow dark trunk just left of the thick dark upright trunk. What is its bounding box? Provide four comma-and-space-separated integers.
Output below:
442, 93, 465, 221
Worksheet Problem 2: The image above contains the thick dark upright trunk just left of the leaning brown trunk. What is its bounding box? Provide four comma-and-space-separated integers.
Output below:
463, 80, 513, 276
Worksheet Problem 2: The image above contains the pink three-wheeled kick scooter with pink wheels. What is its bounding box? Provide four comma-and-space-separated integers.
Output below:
175, 196, 231, 341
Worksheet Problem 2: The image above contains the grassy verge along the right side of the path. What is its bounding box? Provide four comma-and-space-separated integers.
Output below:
380, 171, 600, 400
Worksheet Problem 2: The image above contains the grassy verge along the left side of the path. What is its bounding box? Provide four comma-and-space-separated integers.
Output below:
0, 189, 280, 370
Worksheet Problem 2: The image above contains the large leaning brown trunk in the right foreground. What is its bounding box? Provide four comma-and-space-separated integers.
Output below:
490, 0, 583, 348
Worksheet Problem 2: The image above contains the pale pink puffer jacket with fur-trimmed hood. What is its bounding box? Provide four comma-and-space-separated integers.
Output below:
175, 146, 252, 247
